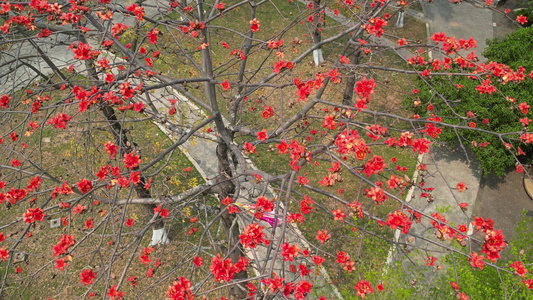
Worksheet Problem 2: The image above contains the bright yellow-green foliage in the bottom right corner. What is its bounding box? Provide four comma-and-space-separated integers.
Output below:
376, 212, 533, 300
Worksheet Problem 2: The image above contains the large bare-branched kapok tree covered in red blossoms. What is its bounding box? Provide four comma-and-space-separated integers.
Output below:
0, 0, 533, 299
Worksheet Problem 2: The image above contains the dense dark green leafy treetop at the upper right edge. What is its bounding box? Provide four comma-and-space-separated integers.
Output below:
405, 28, 533, 175
